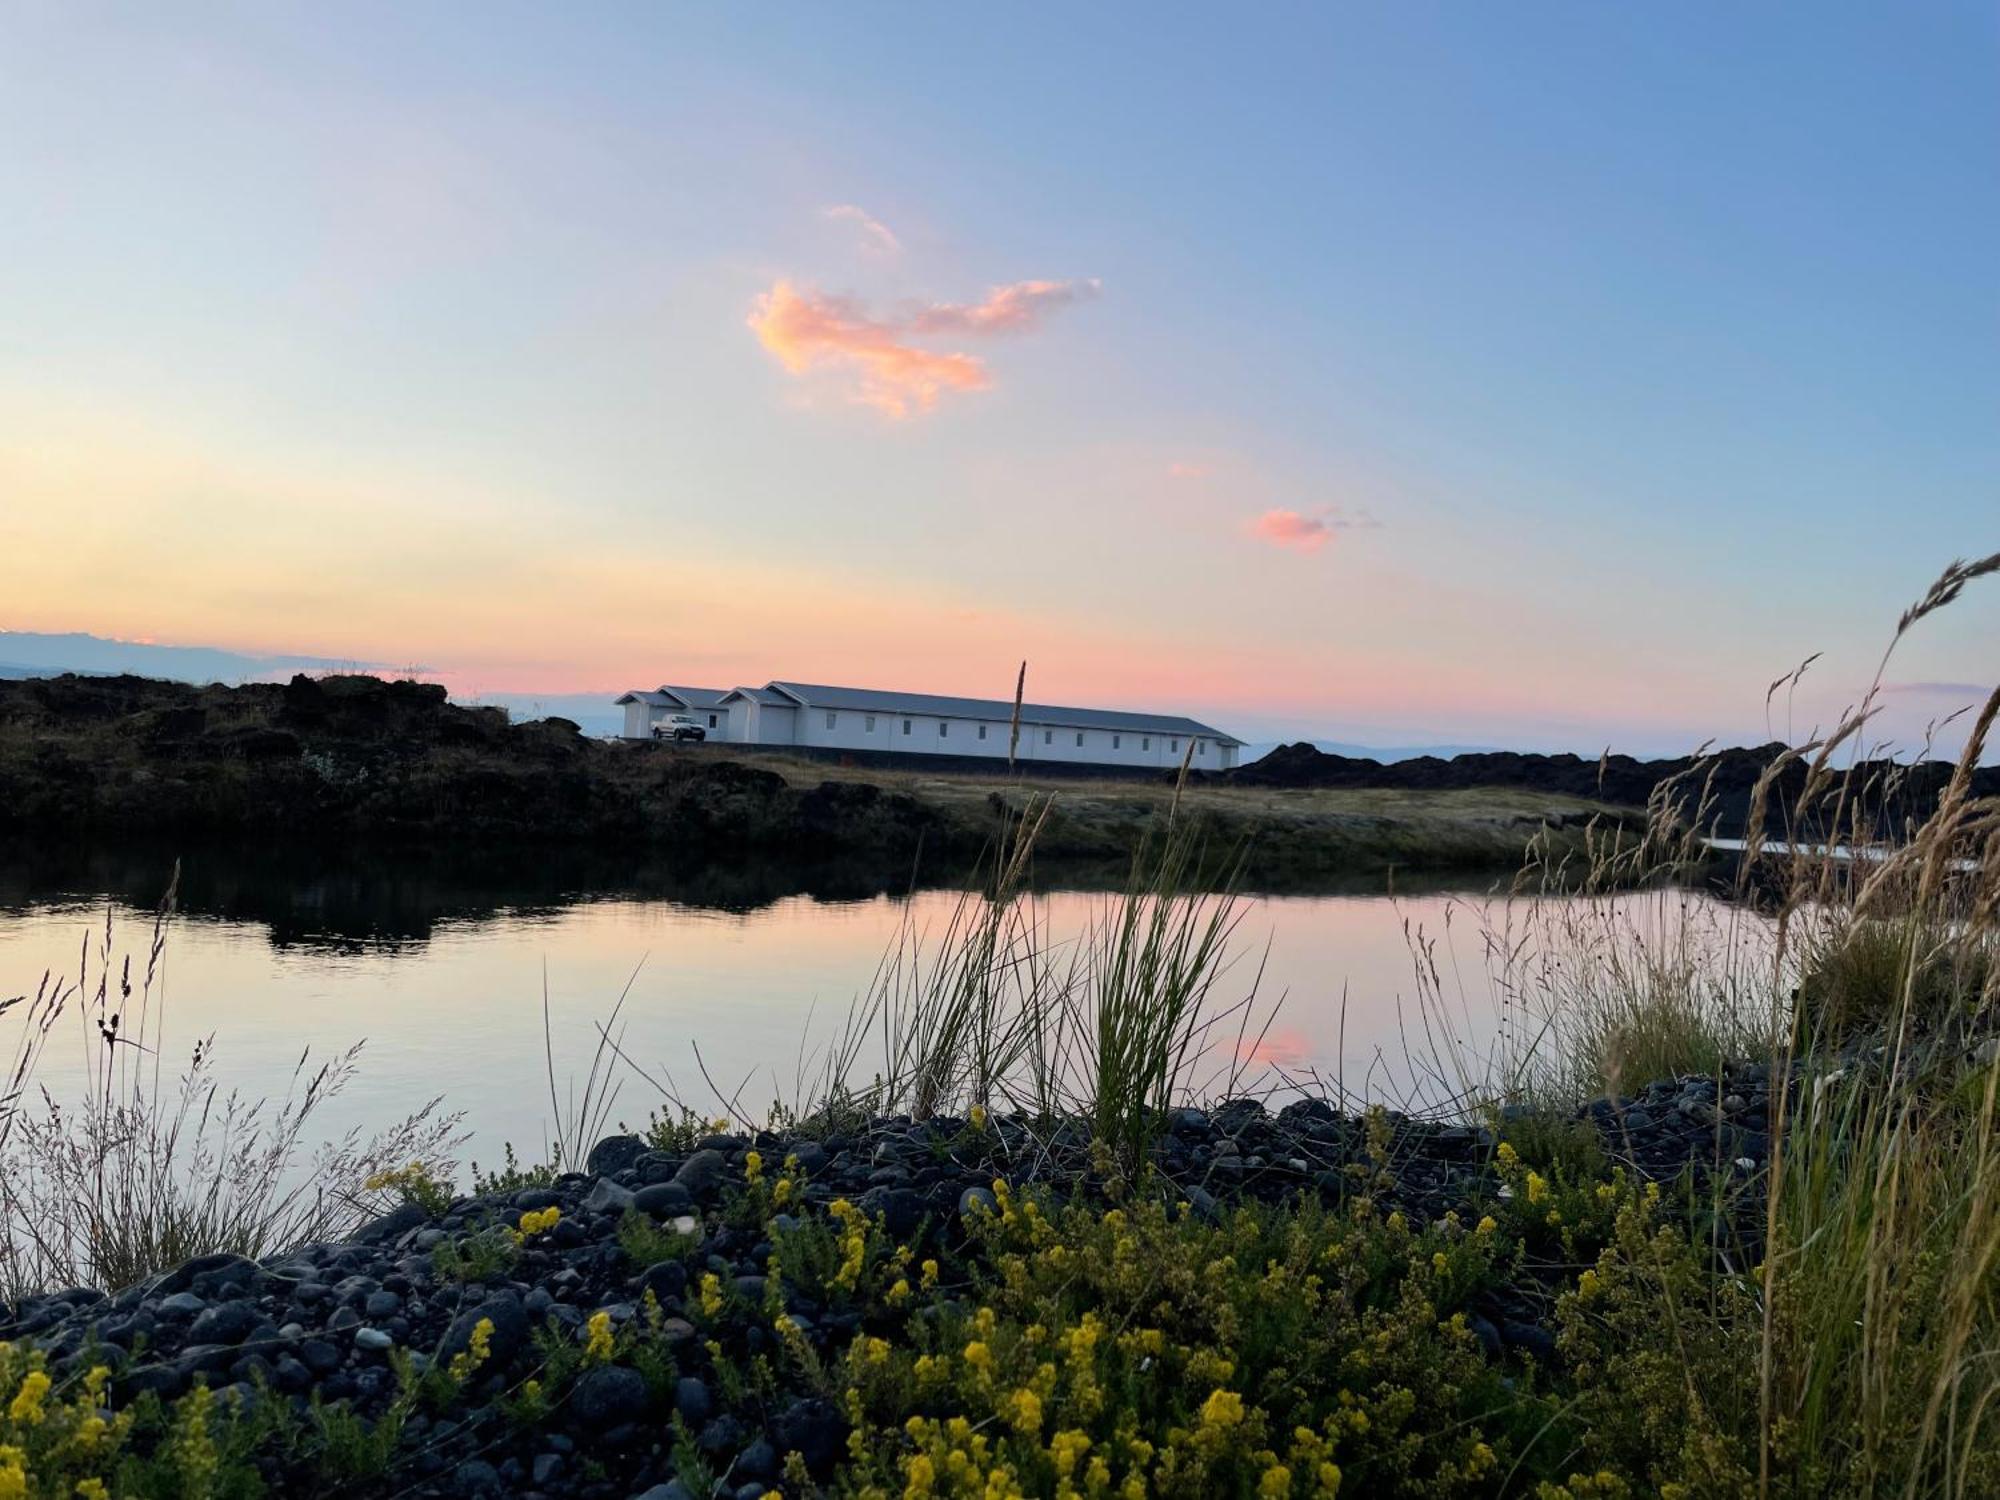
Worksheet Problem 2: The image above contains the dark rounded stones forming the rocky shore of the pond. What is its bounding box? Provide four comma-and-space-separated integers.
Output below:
0, 1066, 1772, 1500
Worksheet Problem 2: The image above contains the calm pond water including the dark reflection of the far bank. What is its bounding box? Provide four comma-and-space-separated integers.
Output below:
0, 850, 1720, 1160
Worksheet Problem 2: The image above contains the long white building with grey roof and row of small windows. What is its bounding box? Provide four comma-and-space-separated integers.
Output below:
616, 682, 1242, 770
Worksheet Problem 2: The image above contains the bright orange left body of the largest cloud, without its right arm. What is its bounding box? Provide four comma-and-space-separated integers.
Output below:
750, 280, 992, 416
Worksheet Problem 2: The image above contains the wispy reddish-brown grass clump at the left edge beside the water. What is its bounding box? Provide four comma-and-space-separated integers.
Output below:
0, 888, 458, 1300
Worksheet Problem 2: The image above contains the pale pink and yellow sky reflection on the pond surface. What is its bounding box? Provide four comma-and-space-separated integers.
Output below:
0, 892, 1760, 1160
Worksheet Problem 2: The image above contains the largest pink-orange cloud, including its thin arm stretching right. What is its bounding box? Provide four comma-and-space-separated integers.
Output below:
748, 278, 1096, 418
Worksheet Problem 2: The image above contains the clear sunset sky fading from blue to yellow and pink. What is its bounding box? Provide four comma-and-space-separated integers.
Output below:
0, 0, 2000, 752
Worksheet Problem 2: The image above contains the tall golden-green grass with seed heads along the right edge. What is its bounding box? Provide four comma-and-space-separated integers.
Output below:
1418, 554, 2000, 1500
